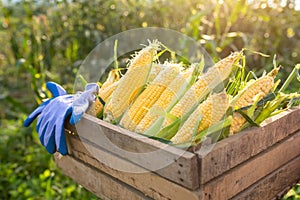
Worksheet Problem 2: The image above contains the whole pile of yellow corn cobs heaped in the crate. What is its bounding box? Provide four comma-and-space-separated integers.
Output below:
81, 41, 298, 148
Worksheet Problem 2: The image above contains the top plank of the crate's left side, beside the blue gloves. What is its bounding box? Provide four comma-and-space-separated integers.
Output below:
67, 115, 199, 190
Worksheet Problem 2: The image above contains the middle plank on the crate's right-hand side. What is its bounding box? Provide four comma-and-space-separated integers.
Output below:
202, 131, 300, 199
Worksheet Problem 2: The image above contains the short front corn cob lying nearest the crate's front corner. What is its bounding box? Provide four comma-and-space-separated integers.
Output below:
171, 91, 229, 144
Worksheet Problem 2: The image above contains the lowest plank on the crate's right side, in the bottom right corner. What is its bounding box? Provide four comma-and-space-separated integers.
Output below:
232, 156, 300, 200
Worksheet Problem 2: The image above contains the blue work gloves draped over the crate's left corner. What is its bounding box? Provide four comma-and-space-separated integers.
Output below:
24, 82, 99, 155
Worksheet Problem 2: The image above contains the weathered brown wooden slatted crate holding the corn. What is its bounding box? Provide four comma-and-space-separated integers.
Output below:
55, 108, 300, 200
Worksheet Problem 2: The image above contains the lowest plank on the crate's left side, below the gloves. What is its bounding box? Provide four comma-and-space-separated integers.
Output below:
55, 153, 149, 200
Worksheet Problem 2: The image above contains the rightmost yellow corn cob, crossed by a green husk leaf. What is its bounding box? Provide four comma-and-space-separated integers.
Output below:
229, 68, 278, 135
